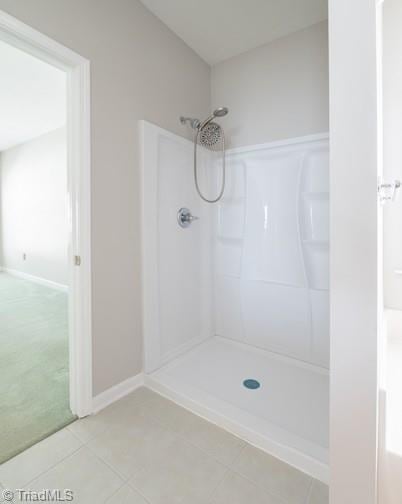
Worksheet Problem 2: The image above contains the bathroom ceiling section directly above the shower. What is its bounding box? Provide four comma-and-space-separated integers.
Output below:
141, 0, 328, 65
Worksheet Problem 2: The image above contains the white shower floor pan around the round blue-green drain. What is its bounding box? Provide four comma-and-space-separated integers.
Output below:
145, 337, 329, 483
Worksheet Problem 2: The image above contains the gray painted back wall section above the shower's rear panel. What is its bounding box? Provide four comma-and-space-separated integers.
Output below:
212, 21, 329, 147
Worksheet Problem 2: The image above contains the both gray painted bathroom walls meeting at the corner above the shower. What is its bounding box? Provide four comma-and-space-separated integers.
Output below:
0, 0, 328, 394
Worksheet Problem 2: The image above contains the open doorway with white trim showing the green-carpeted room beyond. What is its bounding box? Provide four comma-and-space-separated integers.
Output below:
0, 11, 92, 462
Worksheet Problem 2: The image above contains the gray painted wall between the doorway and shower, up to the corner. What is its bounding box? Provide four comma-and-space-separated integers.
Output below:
0, 0, 210, 394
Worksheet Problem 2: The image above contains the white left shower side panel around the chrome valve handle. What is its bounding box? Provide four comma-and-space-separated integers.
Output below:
142, 121, 213, 372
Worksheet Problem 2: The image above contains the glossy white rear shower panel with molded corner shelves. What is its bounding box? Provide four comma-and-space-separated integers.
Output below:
214, 137, 329, 367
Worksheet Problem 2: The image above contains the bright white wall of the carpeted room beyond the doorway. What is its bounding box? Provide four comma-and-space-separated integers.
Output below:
0, 128, 68, 286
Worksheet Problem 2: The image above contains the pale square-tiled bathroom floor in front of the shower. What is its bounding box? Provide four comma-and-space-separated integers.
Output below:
0, 388, 328, 504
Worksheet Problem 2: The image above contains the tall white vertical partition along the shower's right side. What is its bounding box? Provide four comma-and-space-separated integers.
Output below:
329, 0, 382, 504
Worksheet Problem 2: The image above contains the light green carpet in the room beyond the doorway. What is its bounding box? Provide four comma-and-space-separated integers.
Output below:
0, 273, 75, 463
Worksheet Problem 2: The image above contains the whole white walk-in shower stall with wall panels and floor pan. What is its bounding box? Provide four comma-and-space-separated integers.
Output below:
141, 111, 329, 481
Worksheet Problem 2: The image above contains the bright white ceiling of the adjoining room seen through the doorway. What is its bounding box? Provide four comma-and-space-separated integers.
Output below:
0, 41, 66, 151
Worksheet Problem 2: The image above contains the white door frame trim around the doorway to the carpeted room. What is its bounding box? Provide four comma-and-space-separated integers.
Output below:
0, 11, 92, 417
